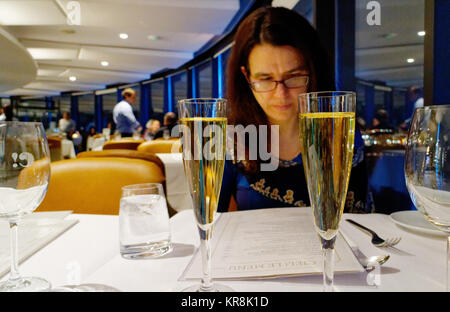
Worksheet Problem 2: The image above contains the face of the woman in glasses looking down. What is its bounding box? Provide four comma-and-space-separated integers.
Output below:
241, 44, 310, 124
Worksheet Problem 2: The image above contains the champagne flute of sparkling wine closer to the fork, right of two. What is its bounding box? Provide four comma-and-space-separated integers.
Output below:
299, 91, 356, 291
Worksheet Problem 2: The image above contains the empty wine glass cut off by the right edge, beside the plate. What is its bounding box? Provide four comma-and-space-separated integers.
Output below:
405, 105, 450, 291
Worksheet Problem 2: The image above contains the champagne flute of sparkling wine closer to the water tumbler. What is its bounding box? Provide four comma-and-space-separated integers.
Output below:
178, 98, 232, 292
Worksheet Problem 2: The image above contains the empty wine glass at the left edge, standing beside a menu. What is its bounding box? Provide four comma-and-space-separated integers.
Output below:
0, 121, 50, 291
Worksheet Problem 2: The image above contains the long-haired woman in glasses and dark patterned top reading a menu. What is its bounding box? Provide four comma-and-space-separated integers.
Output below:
218, 7, 365, 212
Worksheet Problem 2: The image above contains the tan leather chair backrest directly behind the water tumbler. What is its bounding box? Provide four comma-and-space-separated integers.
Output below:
36, 157, 165, 215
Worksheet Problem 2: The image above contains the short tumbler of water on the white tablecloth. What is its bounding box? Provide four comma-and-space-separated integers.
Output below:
119, 183, 172, 259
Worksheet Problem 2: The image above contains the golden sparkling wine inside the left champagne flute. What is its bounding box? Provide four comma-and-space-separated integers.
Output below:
180, 117, 227, 225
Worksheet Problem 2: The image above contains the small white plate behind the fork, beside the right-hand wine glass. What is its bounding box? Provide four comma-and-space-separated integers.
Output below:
390, 210, 445, 235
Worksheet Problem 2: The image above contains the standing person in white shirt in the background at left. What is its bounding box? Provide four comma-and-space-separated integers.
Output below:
113, 88, 142, 137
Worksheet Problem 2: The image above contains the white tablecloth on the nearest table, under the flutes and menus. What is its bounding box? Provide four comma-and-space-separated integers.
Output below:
4, 210, 446, 292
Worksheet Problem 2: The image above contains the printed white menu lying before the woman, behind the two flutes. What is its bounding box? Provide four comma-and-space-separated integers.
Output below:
180, 208, 363, 280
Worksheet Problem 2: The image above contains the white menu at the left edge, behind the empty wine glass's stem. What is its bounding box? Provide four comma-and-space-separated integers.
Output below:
0, 211, 78, 278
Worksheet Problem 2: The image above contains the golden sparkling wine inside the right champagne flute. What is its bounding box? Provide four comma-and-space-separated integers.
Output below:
299, 112, 355, 240
